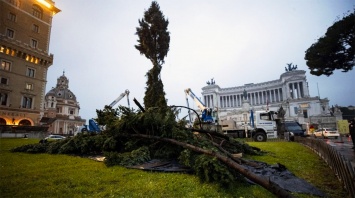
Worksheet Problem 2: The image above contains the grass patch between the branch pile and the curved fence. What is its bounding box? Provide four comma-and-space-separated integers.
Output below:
248, 142, 347, 197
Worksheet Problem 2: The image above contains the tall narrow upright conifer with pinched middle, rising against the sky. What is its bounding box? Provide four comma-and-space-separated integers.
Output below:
135, 1, 170, 112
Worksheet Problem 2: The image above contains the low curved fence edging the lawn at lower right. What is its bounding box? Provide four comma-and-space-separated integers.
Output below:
295, 138, 355, 197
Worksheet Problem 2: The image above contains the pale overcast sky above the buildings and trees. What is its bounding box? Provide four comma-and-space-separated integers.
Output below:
46, 0, 355, 119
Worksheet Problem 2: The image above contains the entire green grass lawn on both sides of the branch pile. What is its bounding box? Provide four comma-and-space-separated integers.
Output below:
0, 138, 346, 198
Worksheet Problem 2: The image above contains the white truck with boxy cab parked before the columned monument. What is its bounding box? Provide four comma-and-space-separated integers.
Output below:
219, 111, 278, 142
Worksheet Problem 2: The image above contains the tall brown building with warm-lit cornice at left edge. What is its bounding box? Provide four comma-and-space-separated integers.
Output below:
0, 0, 60, 126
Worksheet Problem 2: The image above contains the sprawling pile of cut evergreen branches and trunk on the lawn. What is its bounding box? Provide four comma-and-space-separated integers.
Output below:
13, 106, 289, 197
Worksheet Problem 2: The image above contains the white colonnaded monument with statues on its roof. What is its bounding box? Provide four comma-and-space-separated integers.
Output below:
202, 69, 341, 126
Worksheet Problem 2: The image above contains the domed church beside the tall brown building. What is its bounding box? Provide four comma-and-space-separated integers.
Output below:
41, 72, 86, 136
